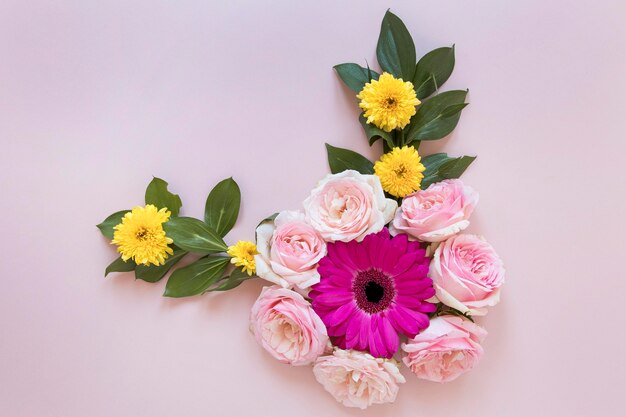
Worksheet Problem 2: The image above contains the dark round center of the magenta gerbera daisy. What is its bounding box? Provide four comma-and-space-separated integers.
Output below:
352, 269, 396, 314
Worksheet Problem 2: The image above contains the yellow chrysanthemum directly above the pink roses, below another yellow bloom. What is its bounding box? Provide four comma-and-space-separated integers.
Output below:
374, 146, 426, 197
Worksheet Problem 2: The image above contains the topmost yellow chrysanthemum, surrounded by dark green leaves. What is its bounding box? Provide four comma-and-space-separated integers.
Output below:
356, 72, 420, 132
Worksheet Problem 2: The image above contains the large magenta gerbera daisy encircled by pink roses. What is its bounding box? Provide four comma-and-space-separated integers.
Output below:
309, 228, 436, 358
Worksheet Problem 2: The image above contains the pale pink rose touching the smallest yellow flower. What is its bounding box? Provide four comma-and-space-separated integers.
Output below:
254, 211, 326, 289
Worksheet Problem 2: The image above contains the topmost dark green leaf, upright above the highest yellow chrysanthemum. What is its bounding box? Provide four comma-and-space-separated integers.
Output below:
376, 10, 417, 81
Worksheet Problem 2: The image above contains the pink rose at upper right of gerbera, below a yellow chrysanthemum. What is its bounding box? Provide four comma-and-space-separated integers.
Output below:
390, 180, 478, 242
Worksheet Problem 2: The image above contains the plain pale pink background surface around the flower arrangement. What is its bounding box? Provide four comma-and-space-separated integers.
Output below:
0, 0, 626, 417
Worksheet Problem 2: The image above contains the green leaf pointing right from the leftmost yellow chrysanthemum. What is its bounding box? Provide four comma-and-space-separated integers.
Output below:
163, 217, 228, 254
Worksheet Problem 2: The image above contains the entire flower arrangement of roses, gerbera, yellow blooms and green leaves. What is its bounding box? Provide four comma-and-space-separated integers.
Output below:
98, 11, 504, 408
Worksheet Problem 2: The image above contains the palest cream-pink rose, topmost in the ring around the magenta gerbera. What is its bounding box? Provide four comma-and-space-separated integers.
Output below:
304, 170, 398, 242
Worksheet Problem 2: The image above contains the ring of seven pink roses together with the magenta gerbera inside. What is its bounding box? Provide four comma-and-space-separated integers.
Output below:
251, 170, 504, 408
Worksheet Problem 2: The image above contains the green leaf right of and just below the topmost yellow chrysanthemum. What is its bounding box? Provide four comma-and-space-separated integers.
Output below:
406, 90, 467, 143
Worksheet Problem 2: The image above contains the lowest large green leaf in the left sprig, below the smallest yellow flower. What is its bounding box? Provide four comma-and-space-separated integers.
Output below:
163, 256, 230, 297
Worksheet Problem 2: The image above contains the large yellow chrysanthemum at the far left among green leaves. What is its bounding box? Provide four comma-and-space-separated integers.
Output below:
111, 204, 174, 265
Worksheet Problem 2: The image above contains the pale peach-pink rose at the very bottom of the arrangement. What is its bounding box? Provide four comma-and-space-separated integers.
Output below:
313, 349, 405, 409
